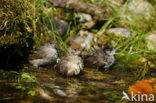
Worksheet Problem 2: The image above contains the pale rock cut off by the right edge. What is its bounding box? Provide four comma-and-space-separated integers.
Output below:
146, 31, 156, 51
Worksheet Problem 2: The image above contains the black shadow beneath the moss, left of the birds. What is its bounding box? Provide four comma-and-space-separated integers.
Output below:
0, 38, 33, 70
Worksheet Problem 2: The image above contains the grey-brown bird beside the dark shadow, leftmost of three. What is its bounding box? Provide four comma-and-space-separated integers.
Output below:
28, 40, 58, 68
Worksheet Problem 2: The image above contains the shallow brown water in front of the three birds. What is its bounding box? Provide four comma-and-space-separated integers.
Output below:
0, 65, 155, 103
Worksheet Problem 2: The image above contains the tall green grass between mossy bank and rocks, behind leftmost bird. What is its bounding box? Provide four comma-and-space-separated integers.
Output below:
24, 0, 67, 52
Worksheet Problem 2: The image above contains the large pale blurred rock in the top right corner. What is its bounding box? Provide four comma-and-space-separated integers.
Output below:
121, 0, 154, 20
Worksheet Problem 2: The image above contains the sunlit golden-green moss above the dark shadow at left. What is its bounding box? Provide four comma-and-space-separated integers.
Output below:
0, 0, 28, 46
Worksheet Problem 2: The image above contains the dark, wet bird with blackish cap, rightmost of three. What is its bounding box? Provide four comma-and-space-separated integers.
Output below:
83, 45, 117, 69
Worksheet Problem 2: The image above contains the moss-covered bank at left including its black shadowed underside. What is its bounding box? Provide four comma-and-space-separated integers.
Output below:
0, 0, 33, 69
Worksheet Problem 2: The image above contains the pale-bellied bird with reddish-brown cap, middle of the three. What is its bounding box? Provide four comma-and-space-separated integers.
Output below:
58, 43, 84, 76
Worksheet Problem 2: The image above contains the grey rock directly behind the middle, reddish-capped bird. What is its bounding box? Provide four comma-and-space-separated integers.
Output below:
70, 31, 93, 49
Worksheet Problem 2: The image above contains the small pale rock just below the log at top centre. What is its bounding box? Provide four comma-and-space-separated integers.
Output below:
78, 13, 92, 22
